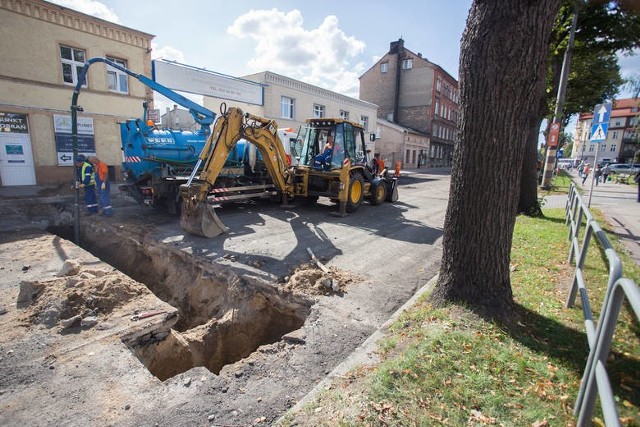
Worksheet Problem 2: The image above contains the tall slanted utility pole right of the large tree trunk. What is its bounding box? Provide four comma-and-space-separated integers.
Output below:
542, 0, 580, 190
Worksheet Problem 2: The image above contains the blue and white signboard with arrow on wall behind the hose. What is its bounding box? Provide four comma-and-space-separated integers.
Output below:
53, 114, 96, 166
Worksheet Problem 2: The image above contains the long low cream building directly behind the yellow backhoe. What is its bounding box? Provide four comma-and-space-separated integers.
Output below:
203, 71, 378, 137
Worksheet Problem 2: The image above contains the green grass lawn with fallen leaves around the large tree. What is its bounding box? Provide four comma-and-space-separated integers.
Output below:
284, 205, 640, 427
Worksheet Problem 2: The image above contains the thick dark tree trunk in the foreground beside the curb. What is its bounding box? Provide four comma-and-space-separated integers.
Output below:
431, 0, 560, 318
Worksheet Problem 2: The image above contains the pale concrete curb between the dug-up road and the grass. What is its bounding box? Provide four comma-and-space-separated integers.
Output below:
274, 275, 438, 425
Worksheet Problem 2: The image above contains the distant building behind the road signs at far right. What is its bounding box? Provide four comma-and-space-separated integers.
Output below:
571, 98, 640, 164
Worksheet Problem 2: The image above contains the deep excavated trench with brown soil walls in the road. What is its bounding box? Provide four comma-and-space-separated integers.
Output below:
48, 217, 312, 381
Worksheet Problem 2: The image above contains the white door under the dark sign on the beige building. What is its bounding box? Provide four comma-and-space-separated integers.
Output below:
0, 132, 36, 187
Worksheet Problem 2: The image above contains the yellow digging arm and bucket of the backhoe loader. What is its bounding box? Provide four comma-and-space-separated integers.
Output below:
180, 108, 290, 237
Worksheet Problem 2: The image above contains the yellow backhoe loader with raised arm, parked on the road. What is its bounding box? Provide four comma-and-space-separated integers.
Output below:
180, 108, 398, 237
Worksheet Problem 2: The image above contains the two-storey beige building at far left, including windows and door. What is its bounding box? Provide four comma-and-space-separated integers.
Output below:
0, 0, 154, 186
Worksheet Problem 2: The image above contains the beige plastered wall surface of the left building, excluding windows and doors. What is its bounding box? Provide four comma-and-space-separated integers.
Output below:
0, 0, 154, 184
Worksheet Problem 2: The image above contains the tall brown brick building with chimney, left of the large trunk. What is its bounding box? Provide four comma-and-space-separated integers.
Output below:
360, 39, 459, 166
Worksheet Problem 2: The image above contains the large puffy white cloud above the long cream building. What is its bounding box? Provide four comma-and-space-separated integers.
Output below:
227, 9, 365, 97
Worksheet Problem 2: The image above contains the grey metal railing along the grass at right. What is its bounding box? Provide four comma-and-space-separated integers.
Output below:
566, 184, 640, 426
